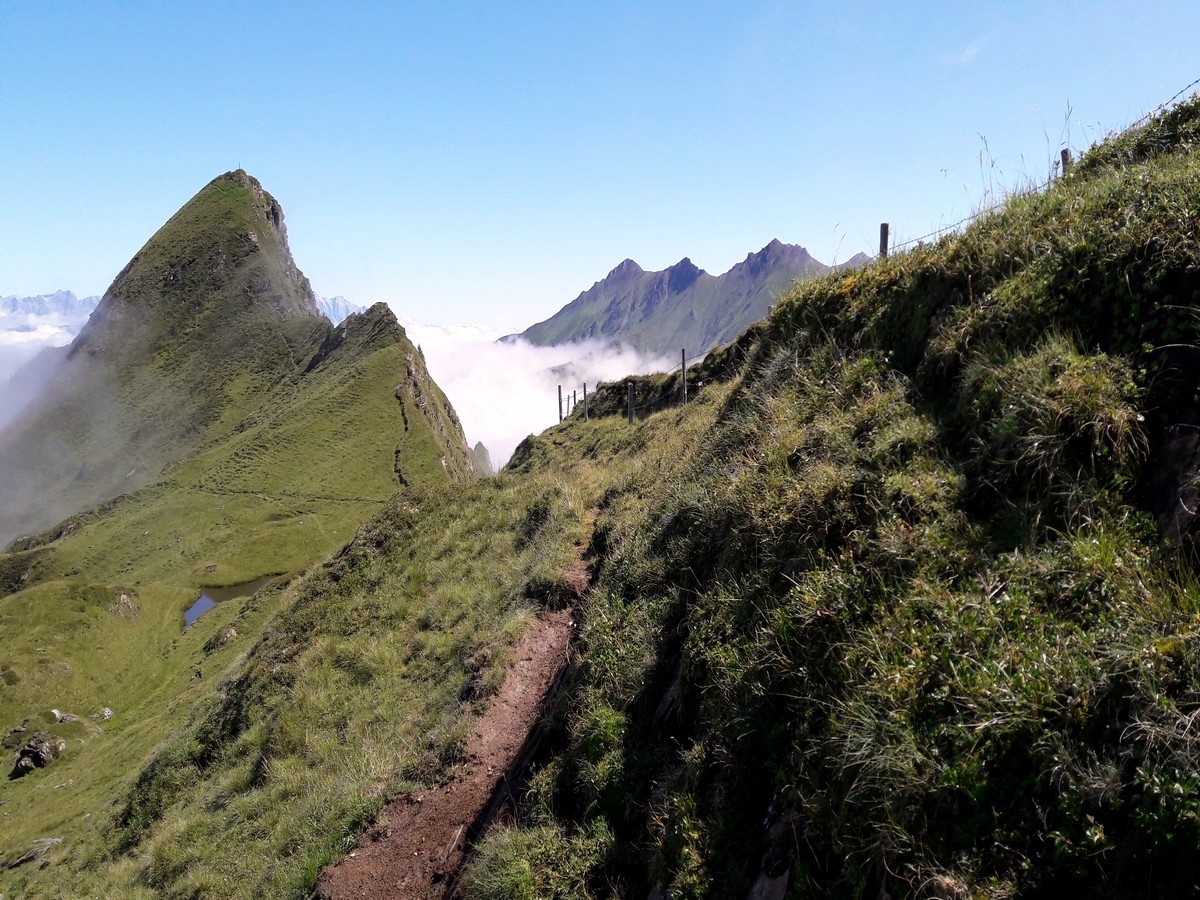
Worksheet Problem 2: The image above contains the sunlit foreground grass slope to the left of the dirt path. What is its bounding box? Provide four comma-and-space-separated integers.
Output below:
6, 478, 588, 896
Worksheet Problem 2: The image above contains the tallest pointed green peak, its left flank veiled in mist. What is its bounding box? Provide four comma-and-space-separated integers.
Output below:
0, 169, 331, 545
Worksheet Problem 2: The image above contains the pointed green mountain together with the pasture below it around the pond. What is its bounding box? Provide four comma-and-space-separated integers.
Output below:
0, 173, 473, 895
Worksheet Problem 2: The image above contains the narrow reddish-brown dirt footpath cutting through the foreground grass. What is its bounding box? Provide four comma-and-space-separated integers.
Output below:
317, 610, 572, 900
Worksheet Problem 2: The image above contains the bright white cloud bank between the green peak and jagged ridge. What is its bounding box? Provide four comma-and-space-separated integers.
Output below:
402, 320, 676, 468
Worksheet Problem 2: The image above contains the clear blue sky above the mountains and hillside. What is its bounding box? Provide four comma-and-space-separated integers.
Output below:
0, 0, 1200, 328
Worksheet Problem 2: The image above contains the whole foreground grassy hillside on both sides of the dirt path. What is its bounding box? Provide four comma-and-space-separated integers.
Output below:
14, 98, 1200, 900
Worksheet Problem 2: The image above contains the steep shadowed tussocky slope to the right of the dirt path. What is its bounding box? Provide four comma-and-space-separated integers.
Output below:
468, 100, 1200, 896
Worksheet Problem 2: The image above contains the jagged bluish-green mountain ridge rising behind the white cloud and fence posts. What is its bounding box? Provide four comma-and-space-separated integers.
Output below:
516, 240, 870, 354
